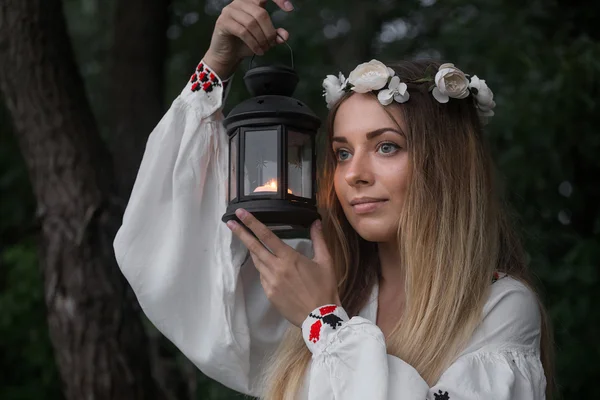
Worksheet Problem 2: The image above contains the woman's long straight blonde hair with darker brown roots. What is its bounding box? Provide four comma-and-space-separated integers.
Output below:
255, 61, 554, 400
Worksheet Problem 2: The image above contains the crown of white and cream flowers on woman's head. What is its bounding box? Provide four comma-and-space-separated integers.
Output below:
323, 60, 496, 122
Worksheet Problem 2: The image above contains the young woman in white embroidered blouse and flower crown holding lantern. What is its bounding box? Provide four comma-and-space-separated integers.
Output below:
115, 0, 552, 400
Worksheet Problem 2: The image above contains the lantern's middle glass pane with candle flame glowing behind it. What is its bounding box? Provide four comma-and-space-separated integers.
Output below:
244, 129, 280, 197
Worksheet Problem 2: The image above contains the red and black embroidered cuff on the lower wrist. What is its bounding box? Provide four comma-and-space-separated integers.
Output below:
302, 304, 350, 354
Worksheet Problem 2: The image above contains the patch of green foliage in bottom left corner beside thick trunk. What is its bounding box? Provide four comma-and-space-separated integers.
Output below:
0, 240, 63, 400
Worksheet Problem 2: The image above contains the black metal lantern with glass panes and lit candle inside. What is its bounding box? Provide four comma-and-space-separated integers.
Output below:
221, 54, 321, 237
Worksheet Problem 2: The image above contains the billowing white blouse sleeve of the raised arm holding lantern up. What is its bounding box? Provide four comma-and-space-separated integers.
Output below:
114, 62, 313, 395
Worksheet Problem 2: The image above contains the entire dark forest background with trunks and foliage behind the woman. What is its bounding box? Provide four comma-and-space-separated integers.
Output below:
0, 0, 600, 400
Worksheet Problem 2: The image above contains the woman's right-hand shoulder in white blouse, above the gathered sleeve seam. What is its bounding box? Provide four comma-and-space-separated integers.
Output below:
463, 275, 541, 354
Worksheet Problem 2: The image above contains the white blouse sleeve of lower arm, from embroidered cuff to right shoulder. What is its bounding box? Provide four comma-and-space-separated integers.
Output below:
302, 279, 546, 400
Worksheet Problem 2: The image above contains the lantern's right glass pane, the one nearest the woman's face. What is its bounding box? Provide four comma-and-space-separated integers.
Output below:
287, 131, 313, 199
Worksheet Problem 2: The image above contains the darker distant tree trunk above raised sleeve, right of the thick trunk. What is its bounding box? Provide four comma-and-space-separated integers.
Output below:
109, 0, 170, 199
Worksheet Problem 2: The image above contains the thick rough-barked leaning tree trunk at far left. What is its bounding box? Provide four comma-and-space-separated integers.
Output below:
0, 0, 162, 400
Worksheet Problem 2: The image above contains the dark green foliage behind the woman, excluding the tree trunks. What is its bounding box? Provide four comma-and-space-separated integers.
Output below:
0, 0, 600, 399
